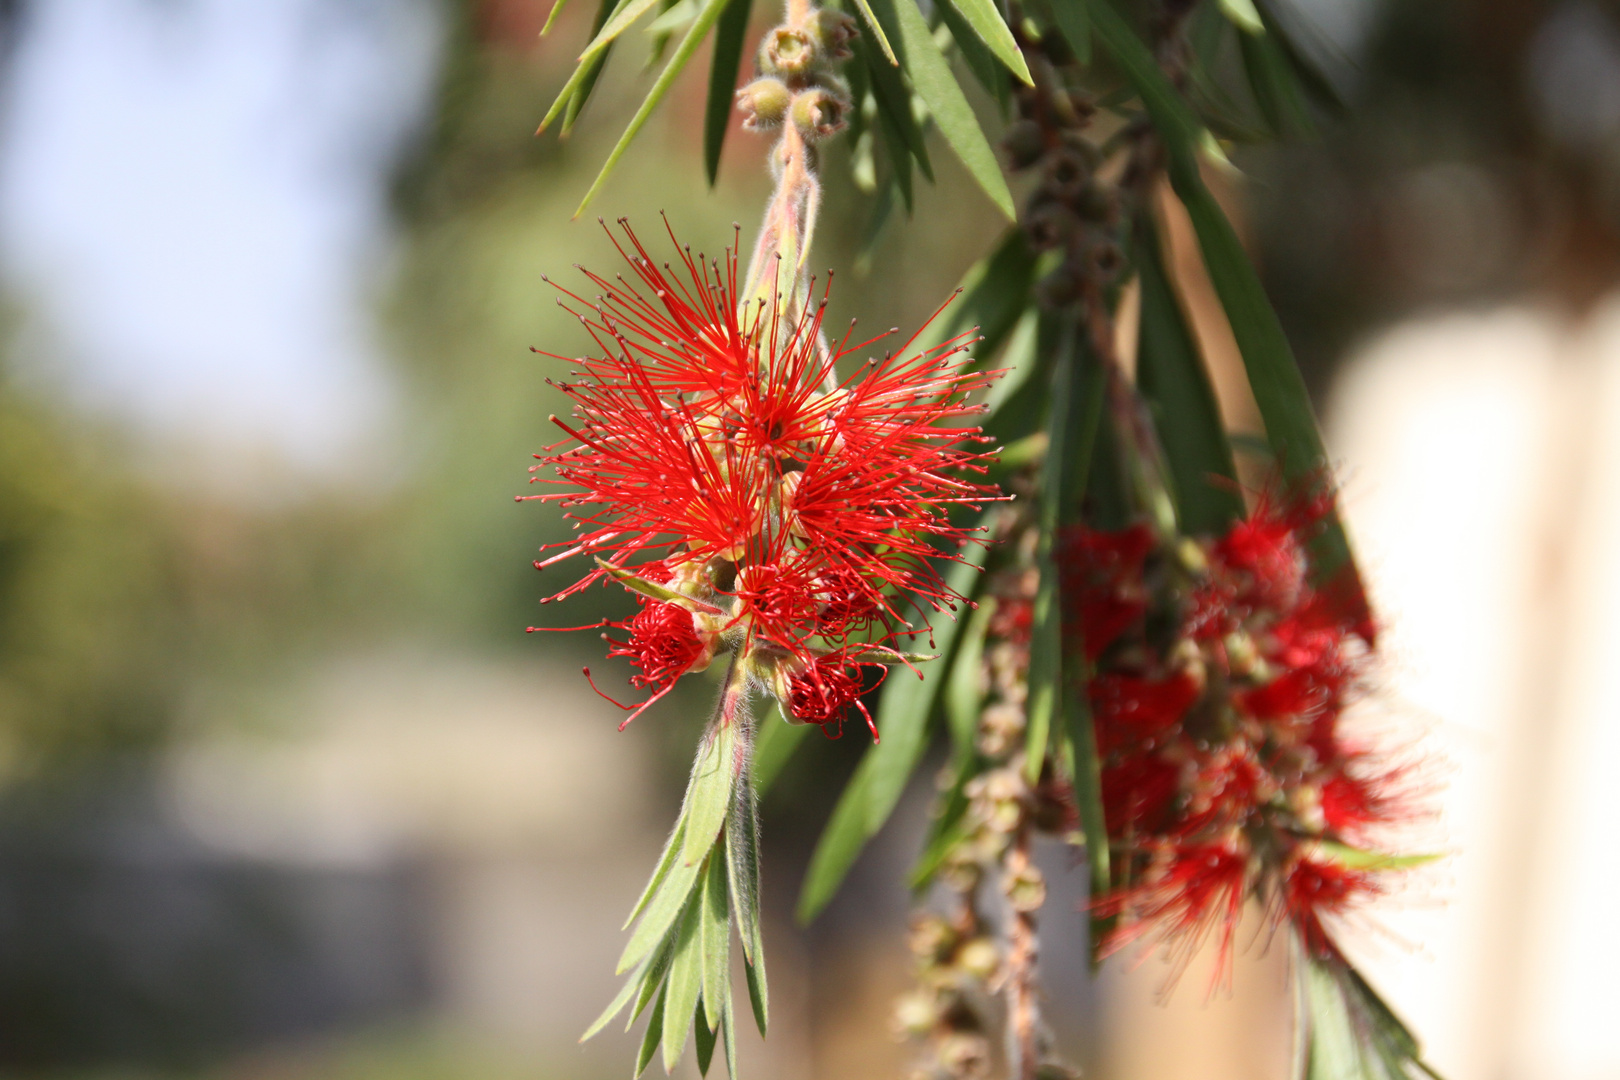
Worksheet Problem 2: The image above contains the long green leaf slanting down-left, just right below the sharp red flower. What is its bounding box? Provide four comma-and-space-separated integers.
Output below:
799, 531, 988, 923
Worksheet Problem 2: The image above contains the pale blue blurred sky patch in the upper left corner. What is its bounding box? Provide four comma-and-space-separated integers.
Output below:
0, 0, 439, 473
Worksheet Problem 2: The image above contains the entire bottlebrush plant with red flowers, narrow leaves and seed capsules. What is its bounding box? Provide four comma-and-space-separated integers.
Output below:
533, 0, 1427, 1080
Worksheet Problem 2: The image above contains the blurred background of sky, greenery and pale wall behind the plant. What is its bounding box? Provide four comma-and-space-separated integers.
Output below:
0, 0, 1620, 1080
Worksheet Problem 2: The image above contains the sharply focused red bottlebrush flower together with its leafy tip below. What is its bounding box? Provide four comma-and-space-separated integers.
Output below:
527, 222, 998, 1075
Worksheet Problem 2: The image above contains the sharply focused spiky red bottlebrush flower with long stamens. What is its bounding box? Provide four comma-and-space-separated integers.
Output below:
527, 222, 995, 725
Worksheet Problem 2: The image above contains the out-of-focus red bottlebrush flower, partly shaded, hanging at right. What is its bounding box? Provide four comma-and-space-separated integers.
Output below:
1059, 497, 1409, 970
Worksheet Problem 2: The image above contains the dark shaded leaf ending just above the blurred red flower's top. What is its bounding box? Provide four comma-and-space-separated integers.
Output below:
1136, 215, 1244, 536
